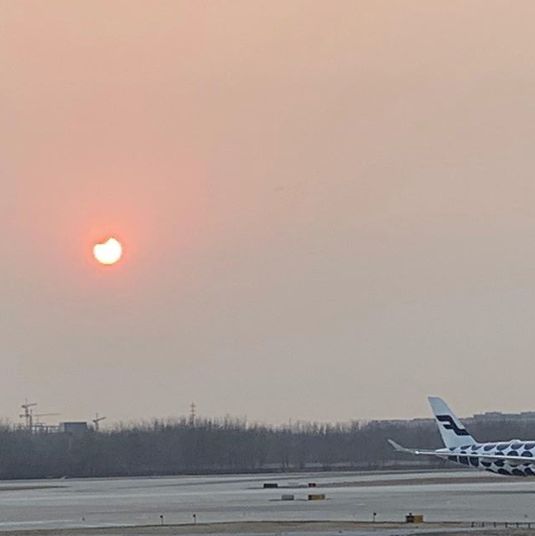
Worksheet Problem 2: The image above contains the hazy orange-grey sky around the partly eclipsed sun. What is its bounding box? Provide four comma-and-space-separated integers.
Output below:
0, 0, 535, 423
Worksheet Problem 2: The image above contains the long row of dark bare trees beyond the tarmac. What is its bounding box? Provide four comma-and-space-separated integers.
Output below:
0, 418, 535, 479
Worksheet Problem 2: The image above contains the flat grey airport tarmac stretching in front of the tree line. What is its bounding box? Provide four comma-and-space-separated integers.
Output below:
0, 471, 535, 536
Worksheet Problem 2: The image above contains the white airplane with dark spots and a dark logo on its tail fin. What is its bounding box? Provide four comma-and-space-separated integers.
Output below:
388, 396, 535, 476
